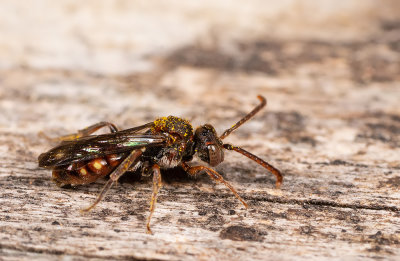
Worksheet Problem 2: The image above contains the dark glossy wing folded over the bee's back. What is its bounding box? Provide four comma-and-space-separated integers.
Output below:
38, 130, 167, 167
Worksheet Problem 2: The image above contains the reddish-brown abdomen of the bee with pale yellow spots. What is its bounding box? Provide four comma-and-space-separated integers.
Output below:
53, 153, 127, 187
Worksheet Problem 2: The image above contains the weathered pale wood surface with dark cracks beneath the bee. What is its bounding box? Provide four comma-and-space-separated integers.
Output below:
0, 1, 400, 260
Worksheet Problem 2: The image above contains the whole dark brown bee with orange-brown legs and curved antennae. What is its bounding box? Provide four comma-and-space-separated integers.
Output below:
39, 96, 282, 233
